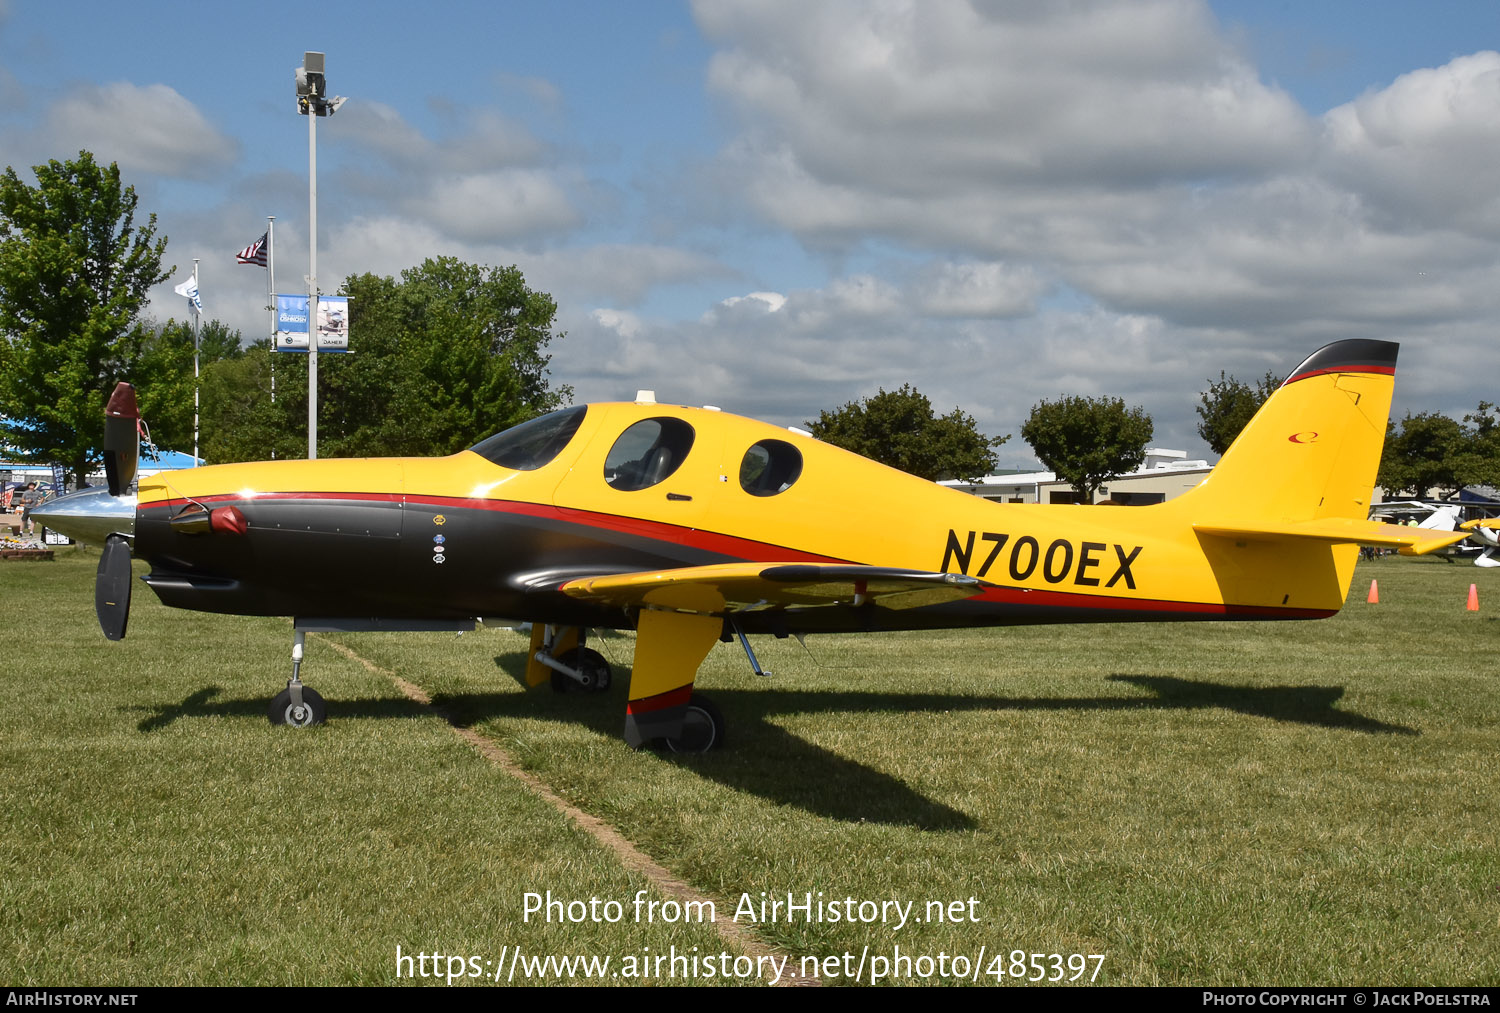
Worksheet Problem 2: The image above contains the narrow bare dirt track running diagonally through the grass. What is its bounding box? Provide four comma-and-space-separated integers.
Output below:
321, 638, 821, 986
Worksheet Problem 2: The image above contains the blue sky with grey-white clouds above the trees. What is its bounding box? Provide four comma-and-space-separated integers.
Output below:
0, 0, 1500, 467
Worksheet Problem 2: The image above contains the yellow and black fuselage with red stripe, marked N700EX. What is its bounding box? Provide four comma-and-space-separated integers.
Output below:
135, 404, 1353, 632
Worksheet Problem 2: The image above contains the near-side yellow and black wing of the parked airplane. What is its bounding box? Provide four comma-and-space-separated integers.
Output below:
561, 563, 989, 615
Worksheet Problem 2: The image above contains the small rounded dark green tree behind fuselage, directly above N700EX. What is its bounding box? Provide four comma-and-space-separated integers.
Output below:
1022, 396, 1154, 503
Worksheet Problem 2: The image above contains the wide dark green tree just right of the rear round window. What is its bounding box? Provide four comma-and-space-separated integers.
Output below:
806, 384, 1010, 480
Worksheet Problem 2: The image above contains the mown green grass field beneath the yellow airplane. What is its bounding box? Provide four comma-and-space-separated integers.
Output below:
0, 552, 1500, 986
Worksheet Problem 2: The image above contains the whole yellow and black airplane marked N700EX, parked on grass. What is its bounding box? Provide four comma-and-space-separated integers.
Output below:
33, 341, 1463, 752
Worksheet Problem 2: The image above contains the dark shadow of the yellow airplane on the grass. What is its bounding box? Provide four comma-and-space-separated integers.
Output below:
138, 669, 1419, 830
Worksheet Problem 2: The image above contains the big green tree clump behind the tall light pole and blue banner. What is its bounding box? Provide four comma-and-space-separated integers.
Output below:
204, 257, 573, 462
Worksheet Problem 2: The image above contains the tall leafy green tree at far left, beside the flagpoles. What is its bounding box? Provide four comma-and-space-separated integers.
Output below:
0, 152, 173, 482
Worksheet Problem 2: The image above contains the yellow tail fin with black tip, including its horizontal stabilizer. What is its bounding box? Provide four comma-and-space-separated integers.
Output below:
1181, 339, 1454, 552
